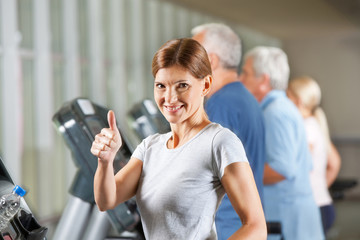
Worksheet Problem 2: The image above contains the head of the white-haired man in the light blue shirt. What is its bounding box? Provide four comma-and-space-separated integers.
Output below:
240, 46, 290, 102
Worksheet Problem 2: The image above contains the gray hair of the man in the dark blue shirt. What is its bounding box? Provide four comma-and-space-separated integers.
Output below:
191, 23, 241, 69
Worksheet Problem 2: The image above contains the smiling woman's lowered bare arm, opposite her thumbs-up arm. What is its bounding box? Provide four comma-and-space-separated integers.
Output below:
221, 162, 267, 240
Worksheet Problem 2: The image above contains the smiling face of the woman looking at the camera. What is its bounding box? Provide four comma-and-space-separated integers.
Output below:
154, 66, 206, 124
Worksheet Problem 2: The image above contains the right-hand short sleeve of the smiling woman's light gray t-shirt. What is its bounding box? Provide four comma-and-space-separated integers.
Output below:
213, 128, 248, 179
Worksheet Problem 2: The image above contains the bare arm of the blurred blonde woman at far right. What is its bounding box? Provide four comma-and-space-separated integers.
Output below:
326, 143, 341, 187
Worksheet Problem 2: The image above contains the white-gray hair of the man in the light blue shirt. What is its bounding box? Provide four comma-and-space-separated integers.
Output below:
245, 46, 290, 90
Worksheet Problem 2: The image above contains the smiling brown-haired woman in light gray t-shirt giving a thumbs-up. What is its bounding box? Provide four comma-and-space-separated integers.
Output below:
91, 39, 266, 240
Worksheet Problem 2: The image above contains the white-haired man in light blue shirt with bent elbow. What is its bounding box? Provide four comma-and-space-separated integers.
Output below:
240, 46, 324, 240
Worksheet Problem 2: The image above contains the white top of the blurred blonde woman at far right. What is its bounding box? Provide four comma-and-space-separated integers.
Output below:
305, 117, 332, 207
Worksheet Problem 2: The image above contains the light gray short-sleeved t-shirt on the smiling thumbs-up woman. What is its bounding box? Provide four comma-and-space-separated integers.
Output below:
133, 123, 248, 240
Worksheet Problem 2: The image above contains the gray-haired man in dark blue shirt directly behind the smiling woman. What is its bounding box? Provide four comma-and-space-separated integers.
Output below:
192, 23, 265, 240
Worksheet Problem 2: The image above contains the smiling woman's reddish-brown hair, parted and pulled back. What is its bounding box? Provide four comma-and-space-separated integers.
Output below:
152, 38, 212, 79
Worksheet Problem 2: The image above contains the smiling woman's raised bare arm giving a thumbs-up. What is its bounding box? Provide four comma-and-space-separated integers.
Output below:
91, 111, 142, 211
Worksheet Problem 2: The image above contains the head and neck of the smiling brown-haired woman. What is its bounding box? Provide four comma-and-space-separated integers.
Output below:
152, 39, 212, 148
